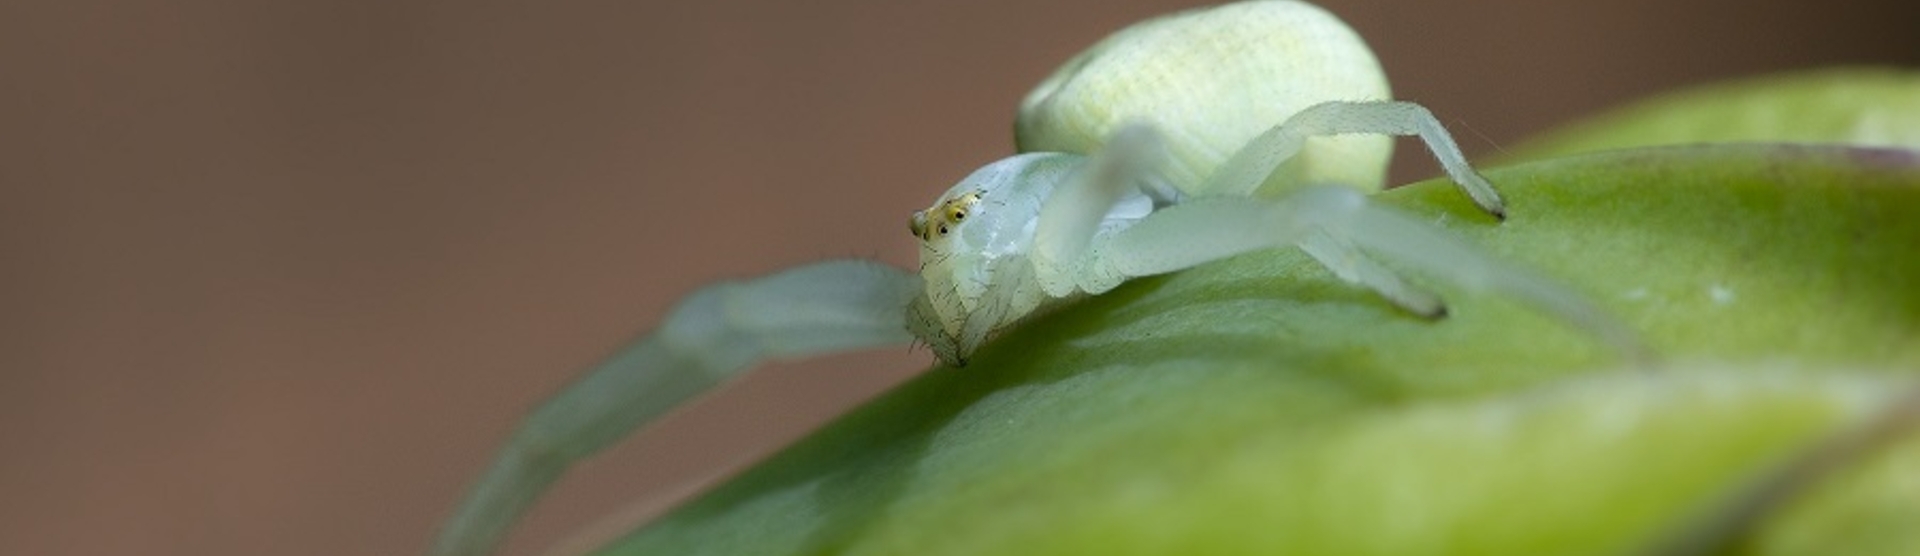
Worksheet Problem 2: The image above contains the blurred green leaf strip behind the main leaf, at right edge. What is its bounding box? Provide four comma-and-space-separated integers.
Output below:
1505, 67, 1920, 161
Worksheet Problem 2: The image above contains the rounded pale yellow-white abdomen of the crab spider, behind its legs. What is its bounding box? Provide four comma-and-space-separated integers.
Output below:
1014, 0, 1392, 196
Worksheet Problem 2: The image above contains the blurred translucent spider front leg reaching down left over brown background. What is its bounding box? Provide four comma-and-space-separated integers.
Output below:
428, 261, 922, 556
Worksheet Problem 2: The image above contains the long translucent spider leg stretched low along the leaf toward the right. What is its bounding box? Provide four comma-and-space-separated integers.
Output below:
1089, 186, 1651, 364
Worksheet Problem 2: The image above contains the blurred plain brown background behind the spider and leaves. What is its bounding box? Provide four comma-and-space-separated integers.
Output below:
0, 0, 1920, 554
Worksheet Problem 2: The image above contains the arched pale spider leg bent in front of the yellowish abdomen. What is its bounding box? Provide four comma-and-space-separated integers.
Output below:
1200, 100, 1507, 220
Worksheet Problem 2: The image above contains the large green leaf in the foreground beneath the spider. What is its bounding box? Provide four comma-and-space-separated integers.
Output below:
605, 146, 1920, 554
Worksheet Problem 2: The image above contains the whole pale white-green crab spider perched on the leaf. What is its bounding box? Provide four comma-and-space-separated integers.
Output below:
430, 2, 1638, 554
